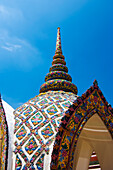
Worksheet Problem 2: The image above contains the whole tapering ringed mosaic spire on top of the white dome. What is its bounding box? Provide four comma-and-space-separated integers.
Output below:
40, 27, 77, 94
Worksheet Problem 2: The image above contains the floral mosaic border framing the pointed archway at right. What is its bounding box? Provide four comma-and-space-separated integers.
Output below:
51, 80, 113, 170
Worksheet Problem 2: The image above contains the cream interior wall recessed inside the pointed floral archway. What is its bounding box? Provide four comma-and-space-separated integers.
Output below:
73, 113, 113, 170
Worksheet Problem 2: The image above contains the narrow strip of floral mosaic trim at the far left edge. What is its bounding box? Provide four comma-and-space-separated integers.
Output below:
0, 97, 8, 170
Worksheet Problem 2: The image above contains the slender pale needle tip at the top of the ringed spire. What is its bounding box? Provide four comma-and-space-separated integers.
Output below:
55, 27, 62, 54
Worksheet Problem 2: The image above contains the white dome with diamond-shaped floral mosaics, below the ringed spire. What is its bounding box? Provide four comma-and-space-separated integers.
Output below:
14, 91, 76, 170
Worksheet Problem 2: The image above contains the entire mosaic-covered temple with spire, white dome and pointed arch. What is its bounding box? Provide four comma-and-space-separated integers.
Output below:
0, 27, 113, 170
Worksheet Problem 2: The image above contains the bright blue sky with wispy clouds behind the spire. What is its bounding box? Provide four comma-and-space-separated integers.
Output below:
0, 0, 113, 109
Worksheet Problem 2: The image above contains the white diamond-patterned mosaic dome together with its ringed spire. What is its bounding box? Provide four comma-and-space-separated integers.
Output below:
13, 28, 77, 170
